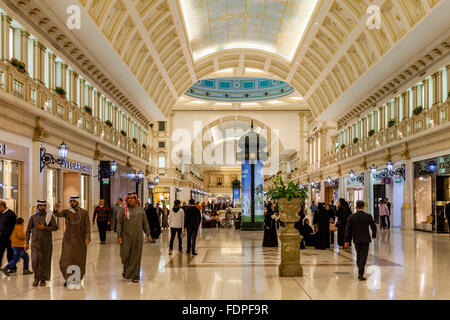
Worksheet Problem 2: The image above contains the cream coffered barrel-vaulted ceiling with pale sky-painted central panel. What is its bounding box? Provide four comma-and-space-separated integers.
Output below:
9, 0, 449, 123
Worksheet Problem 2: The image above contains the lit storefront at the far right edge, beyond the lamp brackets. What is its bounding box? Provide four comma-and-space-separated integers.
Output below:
414, 155, 450, 233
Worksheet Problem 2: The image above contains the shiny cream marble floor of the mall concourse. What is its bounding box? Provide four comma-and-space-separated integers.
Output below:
0, 229, 450, 300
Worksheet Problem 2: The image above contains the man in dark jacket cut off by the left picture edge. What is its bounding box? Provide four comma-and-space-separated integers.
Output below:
0, 201, 17, 273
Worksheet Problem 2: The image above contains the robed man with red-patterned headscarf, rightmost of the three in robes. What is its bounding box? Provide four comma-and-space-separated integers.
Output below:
117, 192, 152, 283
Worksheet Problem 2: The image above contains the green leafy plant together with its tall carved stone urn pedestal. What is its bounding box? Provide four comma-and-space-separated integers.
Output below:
267, 176, 308, 277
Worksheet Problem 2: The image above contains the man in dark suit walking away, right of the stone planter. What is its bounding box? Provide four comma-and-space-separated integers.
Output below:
345, 200, 377, 281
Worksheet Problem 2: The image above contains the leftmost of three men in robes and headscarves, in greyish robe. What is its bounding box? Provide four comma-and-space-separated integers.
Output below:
25, 200, 58, 287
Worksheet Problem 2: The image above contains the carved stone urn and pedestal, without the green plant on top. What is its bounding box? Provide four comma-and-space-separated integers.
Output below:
278, 198, 303, 277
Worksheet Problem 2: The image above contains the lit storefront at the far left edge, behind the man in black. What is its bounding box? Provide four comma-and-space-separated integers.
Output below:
0, 136, 31, 218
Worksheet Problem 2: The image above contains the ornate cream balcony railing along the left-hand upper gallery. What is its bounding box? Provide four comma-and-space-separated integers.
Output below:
0, 62, 150, 161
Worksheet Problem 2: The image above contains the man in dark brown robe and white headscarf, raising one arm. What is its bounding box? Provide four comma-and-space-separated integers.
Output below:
54, 196, 91, 286
